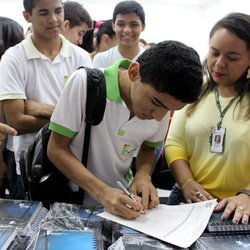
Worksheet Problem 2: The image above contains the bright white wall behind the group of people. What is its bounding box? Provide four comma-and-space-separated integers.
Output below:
0, 0, 250, 59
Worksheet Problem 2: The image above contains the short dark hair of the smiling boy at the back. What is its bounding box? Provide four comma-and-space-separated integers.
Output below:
113, 1, 145, 24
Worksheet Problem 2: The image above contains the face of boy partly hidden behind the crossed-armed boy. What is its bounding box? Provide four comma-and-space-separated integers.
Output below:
61, 20, 88, 45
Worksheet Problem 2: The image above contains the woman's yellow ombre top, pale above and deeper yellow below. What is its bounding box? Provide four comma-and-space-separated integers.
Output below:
165, 92, 250, 199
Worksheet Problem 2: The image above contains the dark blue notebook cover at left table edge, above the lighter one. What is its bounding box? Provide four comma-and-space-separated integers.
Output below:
0, 199, 42, 234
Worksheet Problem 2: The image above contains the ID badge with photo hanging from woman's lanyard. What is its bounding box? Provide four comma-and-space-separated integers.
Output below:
210, 128, 226, 153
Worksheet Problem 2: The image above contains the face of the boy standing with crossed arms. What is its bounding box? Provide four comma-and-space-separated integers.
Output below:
23, 0, 64, 40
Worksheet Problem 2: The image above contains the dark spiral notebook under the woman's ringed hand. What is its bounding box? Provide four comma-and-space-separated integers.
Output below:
207, 212, 250, 235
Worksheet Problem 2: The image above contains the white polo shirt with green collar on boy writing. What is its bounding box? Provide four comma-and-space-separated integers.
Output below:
50, 60, 169, 205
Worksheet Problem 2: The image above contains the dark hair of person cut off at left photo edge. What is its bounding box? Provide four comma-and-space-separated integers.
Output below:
0, 17, 24, 59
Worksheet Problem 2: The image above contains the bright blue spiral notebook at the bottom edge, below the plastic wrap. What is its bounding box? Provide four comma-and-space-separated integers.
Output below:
34, 230, 101, 250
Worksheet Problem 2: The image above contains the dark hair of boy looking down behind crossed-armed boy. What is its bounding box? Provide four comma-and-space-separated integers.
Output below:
63, 1, 93, 29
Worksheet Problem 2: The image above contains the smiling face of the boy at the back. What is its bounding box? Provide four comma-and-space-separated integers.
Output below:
113, 13, 145, 47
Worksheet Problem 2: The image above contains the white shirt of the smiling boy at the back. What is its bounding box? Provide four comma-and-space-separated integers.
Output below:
93, 46, 145, 68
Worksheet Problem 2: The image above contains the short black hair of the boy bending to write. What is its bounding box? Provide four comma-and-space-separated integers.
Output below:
137, 40, 203, 103
